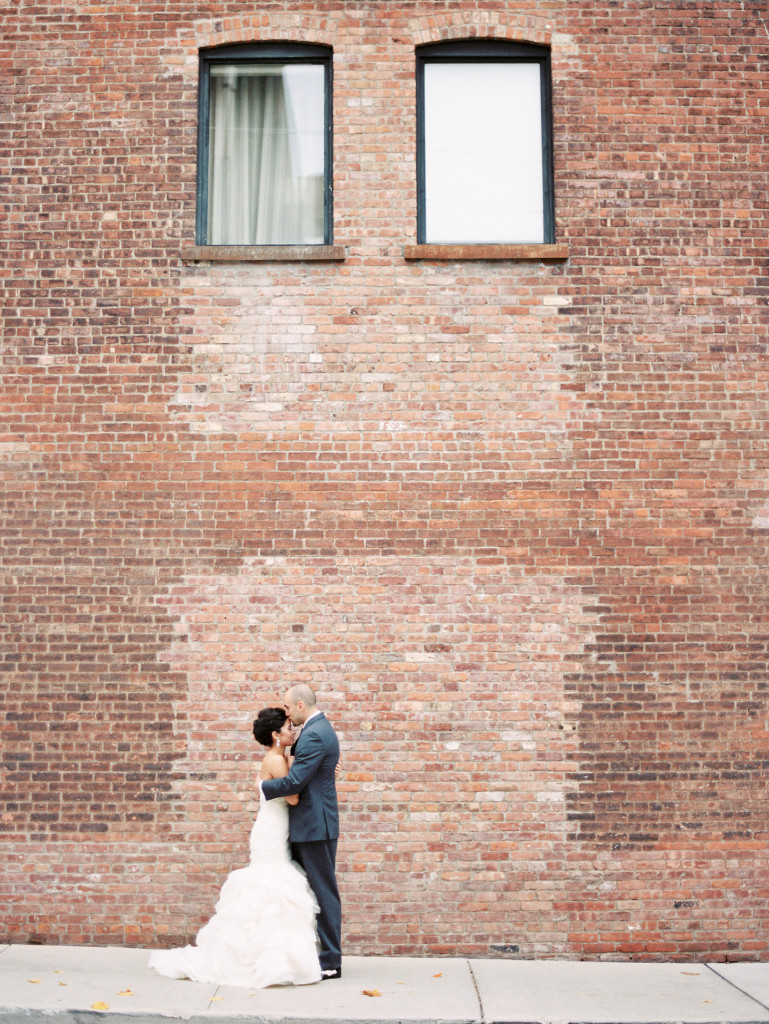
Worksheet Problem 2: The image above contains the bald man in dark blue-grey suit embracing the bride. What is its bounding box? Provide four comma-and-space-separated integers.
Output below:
261, 683, 342, 981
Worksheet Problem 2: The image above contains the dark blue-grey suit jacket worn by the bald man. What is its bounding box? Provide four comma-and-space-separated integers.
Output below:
262, 712, 339, 843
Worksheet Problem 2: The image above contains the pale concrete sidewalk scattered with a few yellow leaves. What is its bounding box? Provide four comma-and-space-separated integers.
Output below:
0, 945, 769, 1024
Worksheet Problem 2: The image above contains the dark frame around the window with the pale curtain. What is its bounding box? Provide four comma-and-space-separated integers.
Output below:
195, 42, 334, 248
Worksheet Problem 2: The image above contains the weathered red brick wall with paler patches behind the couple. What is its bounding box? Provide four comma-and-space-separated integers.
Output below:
0, 0, 769, 959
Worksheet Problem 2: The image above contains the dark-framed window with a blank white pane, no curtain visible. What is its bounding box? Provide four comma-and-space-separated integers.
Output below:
417, 40, 555, 245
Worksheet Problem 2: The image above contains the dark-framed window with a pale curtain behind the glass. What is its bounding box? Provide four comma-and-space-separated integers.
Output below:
197, 43, 332, 246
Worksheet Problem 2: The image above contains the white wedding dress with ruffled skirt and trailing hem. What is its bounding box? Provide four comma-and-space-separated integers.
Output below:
149, 797, 321, 988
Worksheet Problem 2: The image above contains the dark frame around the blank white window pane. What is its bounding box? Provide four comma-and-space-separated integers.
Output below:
416, 39, 555, 247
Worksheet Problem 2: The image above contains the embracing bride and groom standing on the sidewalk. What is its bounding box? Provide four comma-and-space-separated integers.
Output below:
149, 683, 342, 988
